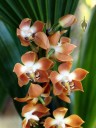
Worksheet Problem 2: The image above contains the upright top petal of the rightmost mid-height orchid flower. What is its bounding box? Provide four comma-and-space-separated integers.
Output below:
58, 62, 72, 73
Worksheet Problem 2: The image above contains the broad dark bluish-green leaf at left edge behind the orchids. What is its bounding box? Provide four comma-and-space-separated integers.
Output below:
0, 22, 27, 113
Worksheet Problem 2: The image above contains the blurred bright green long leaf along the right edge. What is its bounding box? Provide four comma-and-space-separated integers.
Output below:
74, 7, 96, 128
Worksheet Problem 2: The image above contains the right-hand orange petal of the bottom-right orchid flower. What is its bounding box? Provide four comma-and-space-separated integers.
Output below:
65, 115, 84, 127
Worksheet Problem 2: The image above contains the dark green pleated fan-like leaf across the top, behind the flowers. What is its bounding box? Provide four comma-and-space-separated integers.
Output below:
0, 0, 79, 27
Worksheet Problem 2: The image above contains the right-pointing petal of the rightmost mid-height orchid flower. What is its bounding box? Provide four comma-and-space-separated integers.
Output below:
70, 68, 88, 81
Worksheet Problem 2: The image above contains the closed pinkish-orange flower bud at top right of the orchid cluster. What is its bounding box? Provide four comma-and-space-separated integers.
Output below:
59, 14, 77, 28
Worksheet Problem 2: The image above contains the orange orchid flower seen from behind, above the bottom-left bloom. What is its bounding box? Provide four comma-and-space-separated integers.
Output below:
14, 83, 51, 106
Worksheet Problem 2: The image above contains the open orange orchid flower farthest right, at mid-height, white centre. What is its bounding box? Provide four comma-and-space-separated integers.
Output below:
50, 62, 88, 102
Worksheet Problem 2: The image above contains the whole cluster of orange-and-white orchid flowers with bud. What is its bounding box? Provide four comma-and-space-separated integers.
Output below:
13, 15, 88, 128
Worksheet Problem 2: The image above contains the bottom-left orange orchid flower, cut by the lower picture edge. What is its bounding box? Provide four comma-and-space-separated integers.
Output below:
22, 103, 49, 128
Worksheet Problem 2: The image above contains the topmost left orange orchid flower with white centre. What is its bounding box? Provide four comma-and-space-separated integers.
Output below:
17, 18, 49, 49
